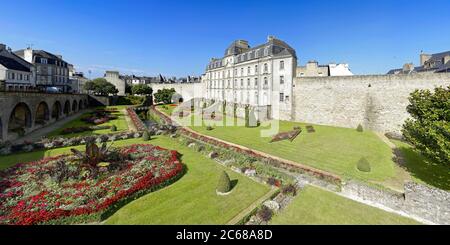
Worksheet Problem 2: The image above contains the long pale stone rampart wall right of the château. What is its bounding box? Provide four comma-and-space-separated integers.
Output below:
292, 73, 450, 134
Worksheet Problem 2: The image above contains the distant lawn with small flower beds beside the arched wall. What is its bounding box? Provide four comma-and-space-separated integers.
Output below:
47, 106, 128, 137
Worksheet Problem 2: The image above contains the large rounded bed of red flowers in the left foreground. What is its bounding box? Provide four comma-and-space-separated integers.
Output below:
0, 144, 184, 225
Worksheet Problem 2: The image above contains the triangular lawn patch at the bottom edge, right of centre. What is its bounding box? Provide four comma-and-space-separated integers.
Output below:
271, 186, 419, 225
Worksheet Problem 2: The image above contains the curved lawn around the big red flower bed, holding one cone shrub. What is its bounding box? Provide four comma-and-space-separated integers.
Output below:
0, 136, 270, 224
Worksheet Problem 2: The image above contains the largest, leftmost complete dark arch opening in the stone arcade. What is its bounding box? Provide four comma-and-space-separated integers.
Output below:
8, 102, 33, 136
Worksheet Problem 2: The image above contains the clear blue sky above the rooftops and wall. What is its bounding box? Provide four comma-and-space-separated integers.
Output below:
0, 0, 450, 77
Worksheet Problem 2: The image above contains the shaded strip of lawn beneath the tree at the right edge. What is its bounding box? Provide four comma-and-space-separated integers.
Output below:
391, 140, 450, 190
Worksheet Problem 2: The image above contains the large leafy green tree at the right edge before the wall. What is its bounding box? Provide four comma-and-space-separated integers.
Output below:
402, 86, 450, 166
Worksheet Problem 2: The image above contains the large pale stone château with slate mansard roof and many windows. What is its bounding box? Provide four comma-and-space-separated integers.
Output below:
202, 36, 297, 120
